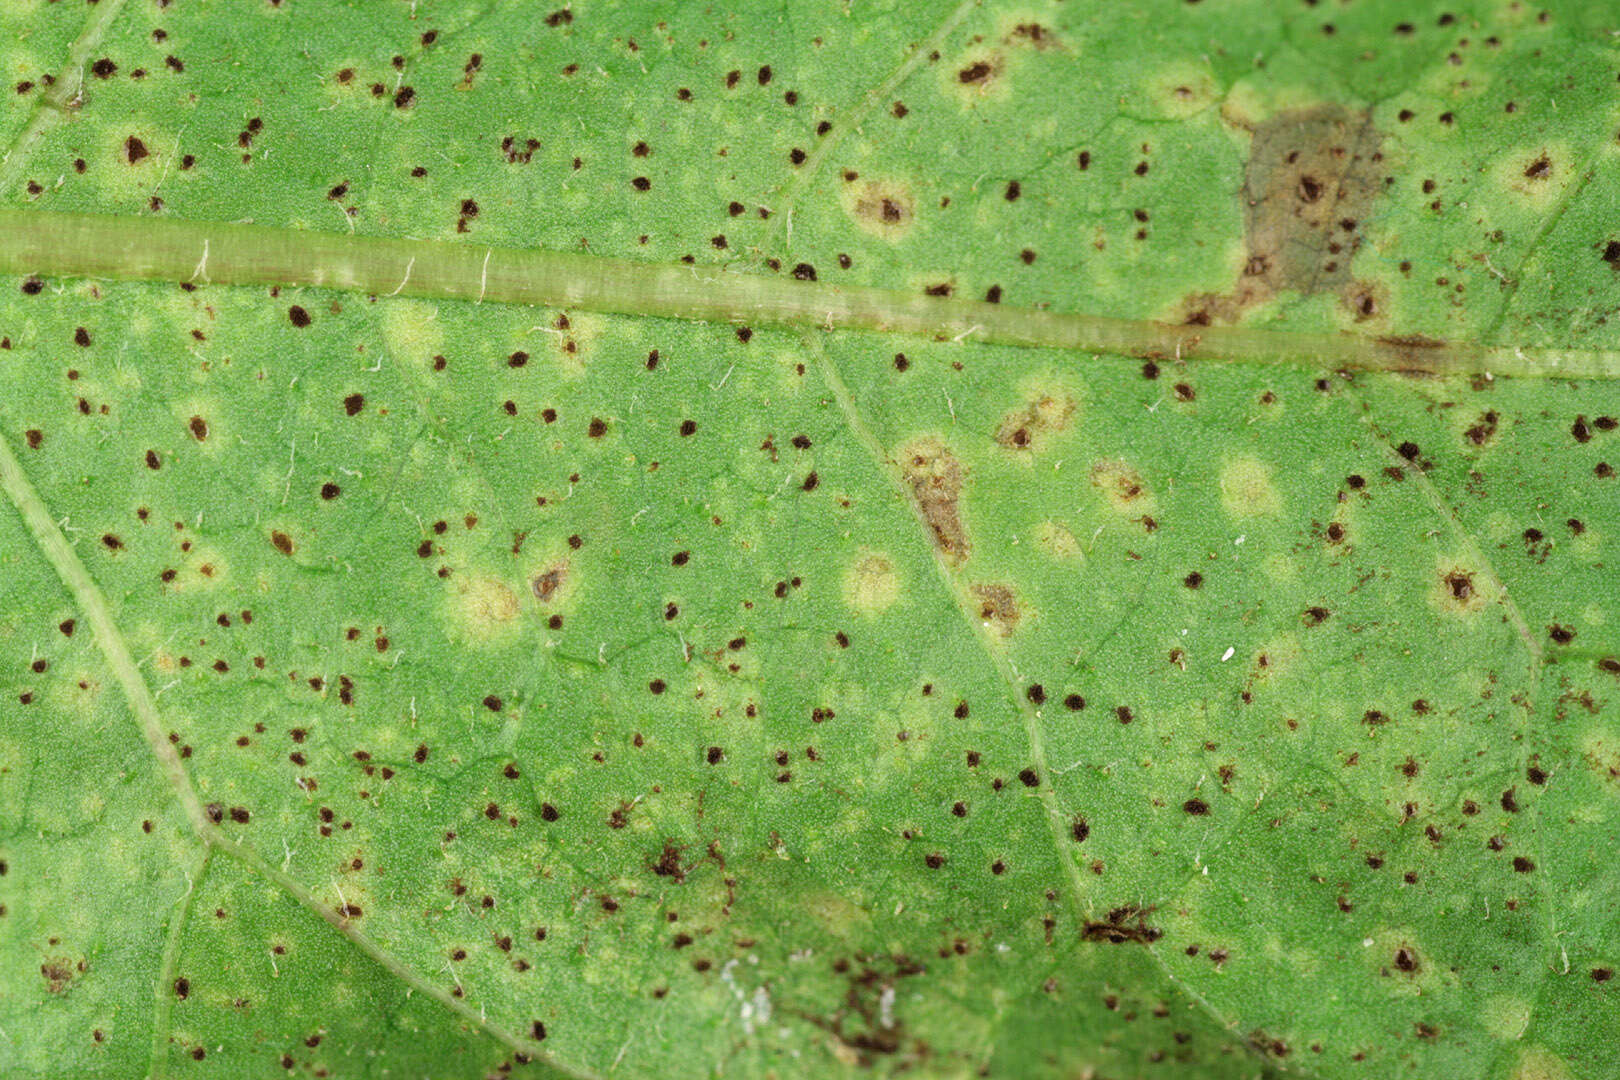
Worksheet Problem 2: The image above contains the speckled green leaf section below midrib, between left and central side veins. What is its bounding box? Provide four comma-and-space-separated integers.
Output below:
11, 287, 1263, 1069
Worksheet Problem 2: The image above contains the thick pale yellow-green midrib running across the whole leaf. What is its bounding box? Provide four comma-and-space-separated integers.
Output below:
0, 209, 1620, 379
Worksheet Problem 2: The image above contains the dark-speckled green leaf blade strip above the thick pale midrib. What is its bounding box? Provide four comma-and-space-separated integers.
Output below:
5, 0, 1620, 348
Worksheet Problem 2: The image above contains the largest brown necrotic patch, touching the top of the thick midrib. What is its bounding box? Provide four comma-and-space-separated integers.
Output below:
1181, 102, 1383, 324
